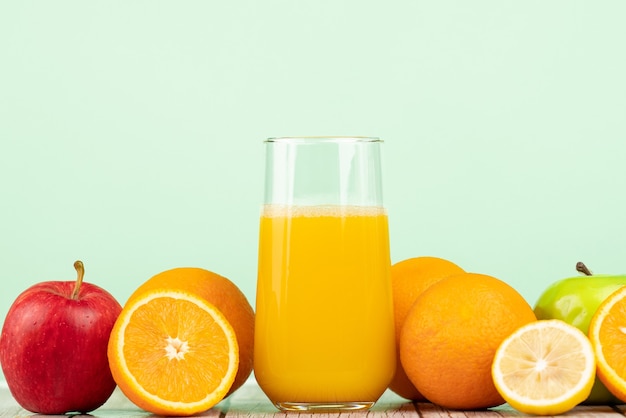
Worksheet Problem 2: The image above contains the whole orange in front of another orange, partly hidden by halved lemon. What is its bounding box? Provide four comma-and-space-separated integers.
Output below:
400, 273, 536, 409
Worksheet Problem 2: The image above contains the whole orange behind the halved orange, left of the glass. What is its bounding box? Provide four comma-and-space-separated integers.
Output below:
127, 267, 254, 396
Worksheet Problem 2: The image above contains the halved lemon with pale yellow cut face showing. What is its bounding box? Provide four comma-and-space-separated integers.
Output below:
491, 319, 596, 415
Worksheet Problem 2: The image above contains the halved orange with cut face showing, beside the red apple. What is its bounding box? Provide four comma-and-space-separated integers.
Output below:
108, 289, 239, 416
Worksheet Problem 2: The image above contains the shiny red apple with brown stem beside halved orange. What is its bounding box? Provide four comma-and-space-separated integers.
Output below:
0, 261, 122, 414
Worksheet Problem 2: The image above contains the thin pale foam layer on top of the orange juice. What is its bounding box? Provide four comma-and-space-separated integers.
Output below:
261, 205, 387, 218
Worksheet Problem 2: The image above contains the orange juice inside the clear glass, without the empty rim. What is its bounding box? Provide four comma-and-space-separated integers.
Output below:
254, 205, 395, 404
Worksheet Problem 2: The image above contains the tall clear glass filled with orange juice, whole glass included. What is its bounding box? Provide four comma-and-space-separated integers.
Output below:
254, 137, 396, 412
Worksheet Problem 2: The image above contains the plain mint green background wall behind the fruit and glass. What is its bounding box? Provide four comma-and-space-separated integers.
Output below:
0, 0, 626, 348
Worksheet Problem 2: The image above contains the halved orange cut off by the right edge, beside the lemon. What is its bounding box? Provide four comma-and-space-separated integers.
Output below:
589, 287, 626, 402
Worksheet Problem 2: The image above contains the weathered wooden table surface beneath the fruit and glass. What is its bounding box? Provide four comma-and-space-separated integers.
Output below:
0, 380, 626, 418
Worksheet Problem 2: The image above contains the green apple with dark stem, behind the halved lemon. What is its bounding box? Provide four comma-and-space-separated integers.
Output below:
535, 262, 626, 405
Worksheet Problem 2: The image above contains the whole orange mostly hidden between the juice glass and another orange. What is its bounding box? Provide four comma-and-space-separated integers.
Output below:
389, 257, 465, 401
